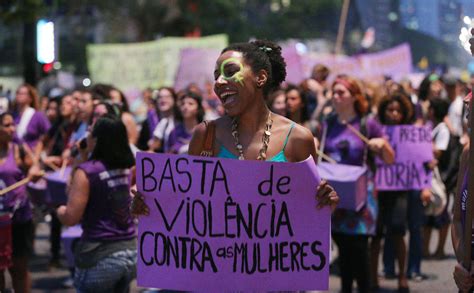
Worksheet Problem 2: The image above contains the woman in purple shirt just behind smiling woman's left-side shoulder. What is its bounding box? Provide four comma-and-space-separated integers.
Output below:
168, 92, 204, 154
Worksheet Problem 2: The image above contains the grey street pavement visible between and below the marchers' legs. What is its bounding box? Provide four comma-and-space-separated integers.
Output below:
1, 222, 457, 293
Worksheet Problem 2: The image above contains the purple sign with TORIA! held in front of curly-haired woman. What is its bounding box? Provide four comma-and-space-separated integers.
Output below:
375, 125, 433, 190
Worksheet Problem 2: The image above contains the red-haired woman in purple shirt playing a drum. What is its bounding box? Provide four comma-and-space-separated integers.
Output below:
321, 76, 395, 292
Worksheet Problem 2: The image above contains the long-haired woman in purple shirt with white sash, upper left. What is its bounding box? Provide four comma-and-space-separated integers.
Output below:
13, 84, 51, 156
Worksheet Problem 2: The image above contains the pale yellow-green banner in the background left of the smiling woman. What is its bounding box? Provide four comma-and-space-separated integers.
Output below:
87, 35, 228, 98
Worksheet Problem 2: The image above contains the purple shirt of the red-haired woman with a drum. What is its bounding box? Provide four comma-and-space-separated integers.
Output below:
324, 116, 383, 166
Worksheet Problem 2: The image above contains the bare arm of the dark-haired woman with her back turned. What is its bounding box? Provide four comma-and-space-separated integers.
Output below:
56, 169, 89, 226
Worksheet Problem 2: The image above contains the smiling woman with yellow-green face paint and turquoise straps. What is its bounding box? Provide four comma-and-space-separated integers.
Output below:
132, 40, 339, 220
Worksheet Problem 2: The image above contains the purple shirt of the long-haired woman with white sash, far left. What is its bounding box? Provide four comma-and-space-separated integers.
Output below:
14, 111, 51, 148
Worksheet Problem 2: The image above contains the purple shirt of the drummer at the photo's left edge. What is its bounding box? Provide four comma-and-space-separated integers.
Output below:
0, 145, 31, 223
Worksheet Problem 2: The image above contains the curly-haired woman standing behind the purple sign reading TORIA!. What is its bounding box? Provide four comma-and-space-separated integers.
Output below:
371, 91, 431, 292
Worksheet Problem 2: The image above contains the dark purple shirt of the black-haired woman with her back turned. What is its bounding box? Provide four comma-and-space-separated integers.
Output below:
78, 161, 135, 241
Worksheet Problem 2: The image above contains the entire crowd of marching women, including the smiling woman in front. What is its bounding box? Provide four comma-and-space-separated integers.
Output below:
0, 34, 474, 292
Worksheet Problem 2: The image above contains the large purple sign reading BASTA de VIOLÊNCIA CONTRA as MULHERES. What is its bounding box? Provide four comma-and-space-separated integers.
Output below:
137, 153, 331, 292
